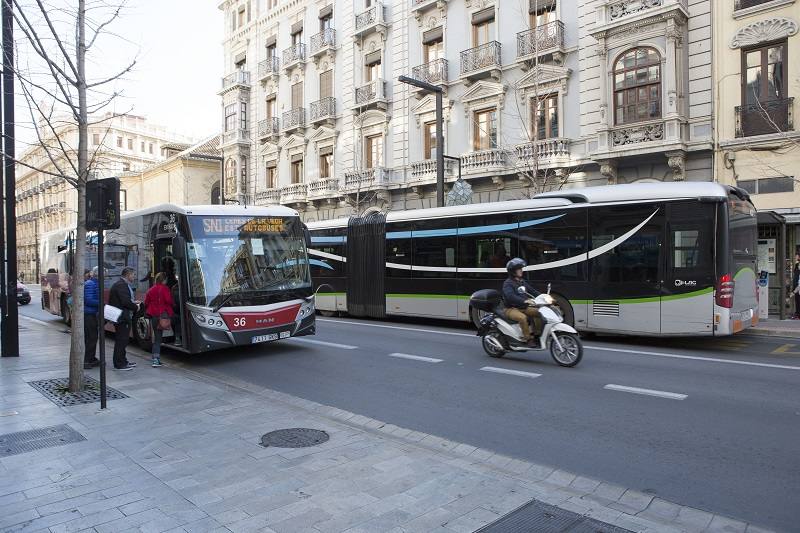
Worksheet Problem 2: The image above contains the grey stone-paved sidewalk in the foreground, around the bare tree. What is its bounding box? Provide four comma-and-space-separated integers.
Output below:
0, 319, 764, 533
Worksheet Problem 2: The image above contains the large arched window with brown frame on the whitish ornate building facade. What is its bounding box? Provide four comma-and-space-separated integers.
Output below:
614, 48, 661, 124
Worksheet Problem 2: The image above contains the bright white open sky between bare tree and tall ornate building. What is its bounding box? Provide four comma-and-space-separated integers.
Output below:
17, 0, 223, 145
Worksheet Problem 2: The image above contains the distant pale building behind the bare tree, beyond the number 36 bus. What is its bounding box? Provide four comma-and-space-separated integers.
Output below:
16, 115, 194, 280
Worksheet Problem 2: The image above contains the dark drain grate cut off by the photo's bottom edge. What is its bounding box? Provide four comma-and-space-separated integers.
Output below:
475, 500, 630, 533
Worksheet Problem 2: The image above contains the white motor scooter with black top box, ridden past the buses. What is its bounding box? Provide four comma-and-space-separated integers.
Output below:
470, 284, 583, 367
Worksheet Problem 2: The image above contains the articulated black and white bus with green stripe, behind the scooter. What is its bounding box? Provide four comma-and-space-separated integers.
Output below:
309, 182, 758, 336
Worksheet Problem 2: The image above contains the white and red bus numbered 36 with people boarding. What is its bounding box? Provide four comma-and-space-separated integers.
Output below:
40, 205, 315, 353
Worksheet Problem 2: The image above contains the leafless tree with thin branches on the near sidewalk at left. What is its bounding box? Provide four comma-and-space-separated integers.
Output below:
9, 0, 135, 392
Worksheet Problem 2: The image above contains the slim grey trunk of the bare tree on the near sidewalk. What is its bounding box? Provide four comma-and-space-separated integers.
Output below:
69, 0, 88, 392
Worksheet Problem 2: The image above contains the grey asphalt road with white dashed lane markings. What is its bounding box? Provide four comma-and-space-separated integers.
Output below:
20, 298, 800, 531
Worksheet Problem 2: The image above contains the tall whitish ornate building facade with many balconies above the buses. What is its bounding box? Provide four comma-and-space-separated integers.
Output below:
219, 0, 712, 220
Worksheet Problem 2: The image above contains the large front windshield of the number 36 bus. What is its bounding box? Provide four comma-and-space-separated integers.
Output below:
187, 215, 311, 307
